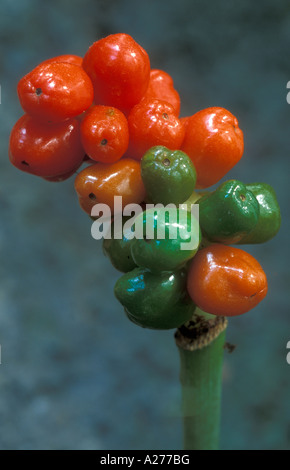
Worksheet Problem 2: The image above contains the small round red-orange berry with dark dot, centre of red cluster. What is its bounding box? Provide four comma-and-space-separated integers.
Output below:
81, 105, 129, 163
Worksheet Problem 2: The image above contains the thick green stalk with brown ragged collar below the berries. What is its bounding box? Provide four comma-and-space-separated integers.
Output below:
175, 310, 227, 450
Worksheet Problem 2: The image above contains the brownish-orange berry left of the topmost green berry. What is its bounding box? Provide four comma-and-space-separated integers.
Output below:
75, 158, 145, 214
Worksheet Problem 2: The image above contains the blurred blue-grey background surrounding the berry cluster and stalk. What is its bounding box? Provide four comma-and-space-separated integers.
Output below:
0, 0, 290, 450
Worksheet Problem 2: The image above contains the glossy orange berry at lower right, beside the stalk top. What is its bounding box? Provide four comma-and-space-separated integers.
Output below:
187, 244, 268, 317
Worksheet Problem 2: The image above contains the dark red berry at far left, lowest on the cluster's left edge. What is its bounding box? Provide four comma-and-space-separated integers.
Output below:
9, 114, 84, 178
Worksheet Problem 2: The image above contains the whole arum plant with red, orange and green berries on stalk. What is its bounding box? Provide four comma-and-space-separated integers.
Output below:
9, 33, 281, 450
